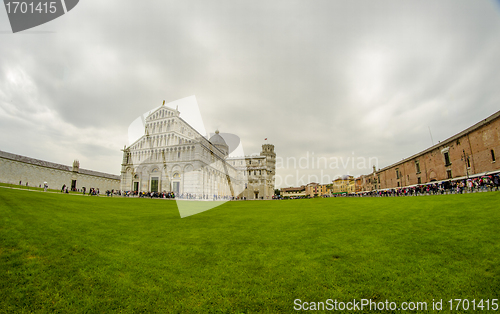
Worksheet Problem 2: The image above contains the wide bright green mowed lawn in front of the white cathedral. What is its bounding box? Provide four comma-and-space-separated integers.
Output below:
0, 188, 500, 313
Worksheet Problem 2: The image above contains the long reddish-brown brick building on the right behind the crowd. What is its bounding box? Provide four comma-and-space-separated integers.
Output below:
356, 111, 500, 191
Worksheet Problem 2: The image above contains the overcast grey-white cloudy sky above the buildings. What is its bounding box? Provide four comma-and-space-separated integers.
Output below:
0, 0, 500, 185
